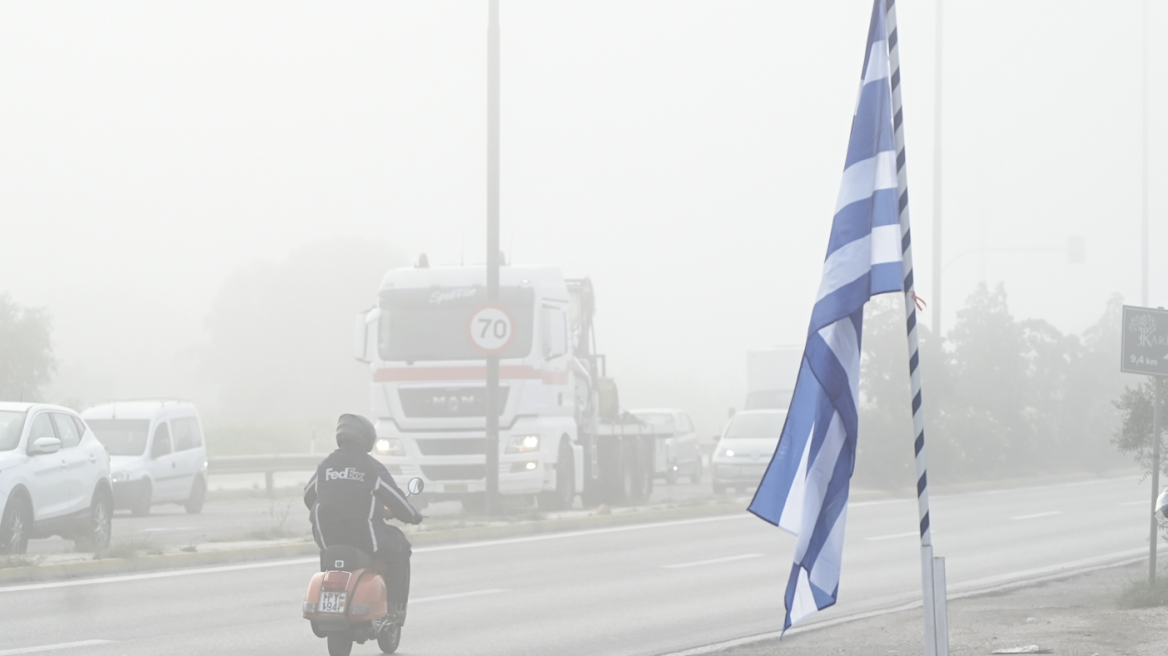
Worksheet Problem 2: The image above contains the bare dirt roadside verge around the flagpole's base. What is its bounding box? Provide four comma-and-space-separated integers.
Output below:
719, 563, 1168, 656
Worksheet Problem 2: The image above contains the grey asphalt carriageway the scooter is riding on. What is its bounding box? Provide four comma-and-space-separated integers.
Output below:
0, 477, 1148, 656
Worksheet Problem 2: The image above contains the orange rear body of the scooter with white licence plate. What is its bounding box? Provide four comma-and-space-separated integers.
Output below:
304, 567, 389, 631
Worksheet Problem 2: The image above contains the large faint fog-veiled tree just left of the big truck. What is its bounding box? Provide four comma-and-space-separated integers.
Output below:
201, 238, 411, 424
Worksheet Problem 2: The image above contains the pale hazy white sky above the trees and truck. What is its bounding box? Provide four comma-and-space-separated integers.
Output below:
0, 0, 1168, 430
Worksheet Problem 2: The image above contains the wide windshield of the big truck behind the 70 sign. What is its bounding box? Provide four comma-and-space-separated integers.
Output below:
377, 286, 535, 362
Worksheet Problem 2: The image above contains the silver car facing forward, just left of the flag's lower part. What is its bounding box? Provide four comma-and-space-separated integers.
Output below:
710, 410, 787, 494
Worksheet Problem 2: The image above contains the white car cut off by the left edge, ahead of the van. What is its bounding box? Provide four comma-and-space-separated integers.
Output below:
0, 403, 113, 553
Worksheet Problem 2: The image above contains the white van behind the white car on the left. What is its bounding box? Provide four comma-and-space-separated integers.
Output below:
81, 400, 207, 515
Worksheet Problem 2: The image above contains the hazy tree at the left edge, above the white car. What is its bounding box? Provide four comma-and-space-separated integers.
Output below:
0, 294, 57, 400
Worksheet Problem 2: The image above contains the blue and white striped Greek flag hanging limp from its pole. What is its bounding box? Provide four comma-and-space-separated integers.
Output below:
750, 0, 903, 630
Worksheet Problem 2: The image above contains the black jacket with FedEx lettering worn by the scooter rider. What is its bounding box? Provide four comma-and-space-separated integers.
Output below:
304, 448, 422, 552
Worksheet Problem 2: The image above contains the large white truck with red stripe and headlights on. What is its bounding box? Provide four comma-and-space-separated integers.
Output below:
354, 265, 666, 511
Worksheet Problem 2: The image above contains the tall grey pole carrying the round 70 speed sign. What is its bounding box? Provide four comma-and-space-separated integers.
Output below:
484, 0, 499, 515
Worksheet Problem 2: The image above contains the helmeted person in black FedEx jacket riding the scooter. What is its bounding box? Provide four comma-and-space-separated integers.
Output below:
304, 414, 422, 623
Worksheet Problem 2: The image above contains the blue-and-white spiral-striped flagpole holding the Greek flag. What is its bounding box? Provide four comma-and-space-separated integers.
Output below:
885, 0, 948, 656
